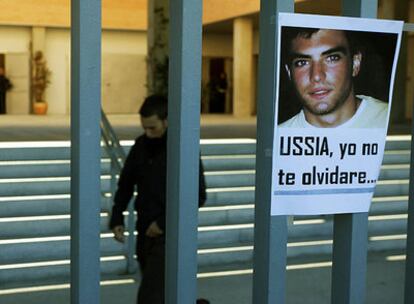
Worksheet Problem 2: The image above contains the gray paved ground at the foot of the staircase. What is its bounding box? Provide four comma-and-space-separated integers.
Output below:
0, 252, 405, 304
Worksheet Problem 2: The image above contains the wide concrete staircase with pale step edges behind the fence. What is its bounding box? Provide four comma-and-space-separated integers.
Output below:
0, 136, 410, 289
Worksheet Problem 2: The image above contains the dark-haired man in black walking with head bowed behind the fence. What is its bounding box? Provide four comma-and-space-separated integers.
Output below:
110, 95, 208, 304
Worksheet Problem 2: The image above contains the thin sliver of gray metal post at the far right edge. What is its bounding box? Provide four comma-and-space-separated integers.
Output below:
404, 96, 414, 304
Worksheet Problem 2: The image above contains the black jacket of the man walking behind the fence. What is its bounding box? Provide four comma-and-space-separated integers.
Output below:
110, 134, 206, 235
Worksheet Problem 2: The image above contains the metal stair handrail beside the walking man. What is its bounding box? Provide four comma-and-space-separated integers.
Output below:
101, 109, 138, 273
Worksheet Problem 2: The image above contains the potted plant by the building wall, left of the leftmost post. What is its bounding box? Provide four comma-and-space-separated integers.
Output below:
32, 51, 51, 114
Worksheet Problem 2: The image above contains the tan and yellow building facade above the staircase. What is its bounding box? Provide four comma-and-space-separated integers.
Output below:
0, 0, 414, 121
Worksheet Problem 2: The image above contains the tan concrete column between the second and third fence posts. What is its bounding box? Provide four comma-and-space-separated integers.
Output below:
233, 17, 254, 117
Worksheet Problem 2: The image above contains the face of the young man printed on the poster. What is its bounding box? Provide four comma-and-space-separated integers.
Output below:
286, 30, 361, 119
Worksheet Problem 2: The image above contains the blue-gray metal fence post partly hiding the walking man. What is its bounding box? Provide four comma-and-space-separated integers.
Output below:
166, 0, 202, 304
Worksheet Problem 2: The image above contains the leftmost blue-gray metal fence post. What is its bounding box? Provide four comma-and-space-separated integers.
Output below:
71, 0, 101, 304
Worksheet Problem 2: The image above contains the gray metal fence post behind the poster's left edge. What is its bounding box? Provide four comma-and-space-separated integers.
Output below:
253, 0, 294, 304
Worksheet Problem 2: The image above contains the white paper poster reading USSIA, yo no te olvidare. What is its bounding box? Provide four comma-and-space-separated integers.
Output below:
271, 13, 403, 215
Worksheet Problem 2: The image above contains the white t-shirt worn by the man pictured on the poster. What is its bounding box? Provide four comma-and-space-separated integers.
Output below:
279, 95, 388, 128
